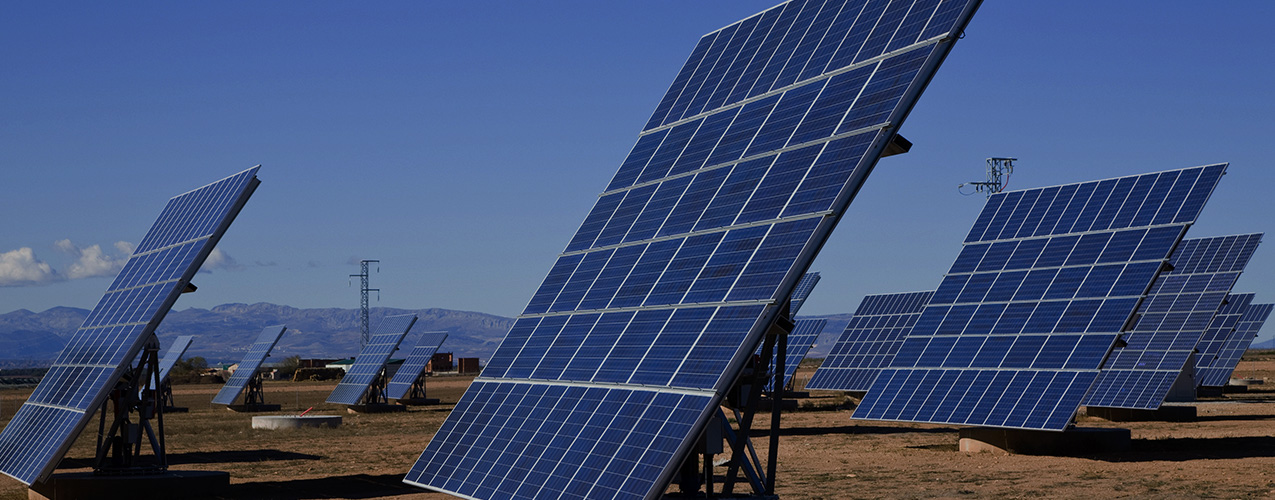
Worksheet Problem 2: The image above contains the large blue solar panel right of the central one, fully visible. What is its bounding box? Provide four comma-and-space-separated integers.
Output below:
853, 165, 1225, 431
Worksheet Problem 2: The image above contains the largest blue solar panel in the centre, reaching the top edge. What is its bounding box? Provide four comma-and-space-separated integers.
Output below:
405, 0, 978, 497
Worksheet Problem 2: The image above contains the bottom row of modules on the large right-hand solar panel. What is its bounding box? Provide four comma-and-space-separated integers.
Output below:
852, 364, 1116, 431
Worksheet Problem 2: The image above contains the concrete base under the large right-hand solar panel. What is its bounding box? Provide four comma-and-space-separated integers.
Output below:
960, 427, 1131, 455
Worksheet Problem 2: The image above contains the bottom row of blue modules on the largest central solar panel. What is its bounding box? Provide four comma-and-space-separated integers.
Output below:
404, 380, 710, 499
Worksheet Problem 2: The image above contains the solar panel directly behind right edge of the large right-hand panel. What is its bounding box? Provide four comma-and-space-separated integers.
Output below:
1084, 233, 1262, 409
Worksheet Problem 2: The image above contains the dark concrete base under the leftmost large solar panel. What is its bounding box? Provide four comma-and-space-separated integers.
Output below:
27, 471, 231, 500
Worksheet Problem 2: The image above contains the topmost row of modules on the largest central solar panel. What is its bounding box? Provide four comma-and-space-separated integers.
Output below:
644, 0, 965, 130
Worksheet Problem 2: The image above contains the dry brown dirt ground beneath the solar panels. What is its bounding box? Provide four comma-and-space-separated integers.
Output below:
0, 355, 1275, 499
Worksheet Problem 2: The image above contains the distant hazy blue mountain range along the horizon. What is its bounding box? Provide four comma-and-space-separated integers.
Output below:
0, 302, 850, 367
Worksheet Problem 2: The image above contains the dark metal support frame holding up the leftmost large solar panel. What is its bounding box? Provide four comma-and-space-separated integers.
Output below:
93, 337, 168, 476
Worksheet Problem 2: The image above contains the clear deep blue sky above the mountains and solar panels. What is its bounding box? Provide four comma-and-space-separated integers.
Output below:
0, 0, 1275, 337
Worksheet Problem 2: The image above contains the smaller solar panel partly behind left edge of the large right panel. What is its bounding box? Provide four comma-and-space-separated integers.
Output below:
806, 291, 935, 392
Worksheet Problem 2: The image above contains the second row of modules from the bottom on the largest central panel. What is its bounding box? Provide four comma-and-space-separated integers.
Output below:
482, 305, 762, 390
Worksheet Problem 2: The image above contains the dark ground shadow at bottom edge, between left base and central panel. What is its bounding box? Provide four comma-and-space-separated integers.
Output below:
222, 473, 425, 500
